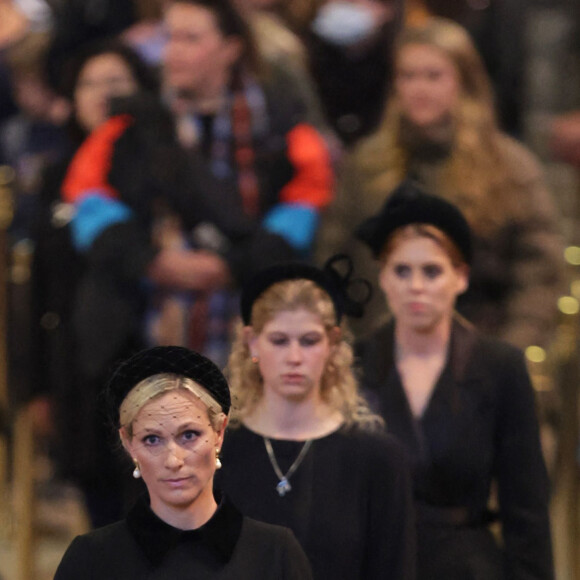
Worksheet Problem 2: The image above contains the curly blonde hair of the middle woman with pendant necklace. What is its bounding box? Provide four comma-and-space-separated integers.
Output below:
226, 279, 383, 430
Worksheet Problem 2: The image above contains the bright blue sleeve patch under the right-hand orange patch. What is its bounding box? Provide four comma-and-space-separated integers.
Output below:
262, 203, 319, 252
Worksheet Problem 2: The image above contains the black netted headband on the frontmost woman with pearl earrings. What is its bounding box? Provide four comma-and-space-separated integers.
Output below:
105, 346, 231, 426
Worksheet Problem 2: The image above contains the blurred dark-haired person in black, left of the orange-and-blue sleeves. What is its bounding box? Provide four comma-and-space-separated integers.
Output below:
27, 40, 158, 526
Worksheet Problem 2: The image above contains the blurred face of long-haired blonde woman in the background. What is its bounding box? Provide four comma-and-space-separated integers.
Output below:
395, 44, 460, 129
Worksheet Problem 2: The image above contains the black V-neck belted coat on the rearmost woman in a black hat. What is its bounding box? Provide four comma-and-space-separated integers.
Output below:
358, 321, 553, 580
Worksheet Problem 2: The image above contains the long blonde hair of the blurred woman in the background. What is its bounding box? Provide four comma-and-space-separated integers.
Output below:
357, 18, 523, 233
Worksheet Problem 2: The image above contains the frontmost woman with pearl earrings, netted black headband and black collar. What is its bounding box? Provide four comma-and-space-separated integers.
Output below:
55, 346, 312, 580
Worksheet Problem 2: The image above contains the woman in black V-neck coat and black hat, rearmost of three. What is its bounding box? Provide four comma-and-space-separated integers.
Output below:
357, 180, 554, 580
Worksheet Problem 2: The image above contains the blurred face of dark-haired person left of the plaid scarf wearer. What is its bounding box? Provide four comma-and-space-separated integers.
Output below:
74, 53, 139, 132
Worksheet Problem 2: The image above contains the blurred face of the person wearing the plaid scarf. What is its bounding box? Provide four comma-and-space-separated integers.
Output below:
163, 2, 241, 99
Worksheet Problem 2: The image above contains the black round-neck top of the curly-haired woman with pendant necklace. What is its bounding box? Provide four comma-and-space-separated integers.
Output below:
216, 426, 415, 580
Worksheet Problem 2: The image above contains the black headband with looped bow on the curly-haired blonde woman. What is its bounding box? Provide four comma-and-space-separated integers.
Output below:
241, 254, 371, 325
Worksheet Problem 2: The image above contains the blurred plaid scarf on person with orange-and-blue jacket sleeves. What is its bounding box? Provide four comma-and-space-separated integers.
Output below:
146, 75, 269, 365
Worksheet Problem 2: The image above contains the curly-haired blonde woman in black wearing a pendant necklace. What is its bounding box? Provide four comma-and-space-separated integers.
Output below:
218, 263, 414, 580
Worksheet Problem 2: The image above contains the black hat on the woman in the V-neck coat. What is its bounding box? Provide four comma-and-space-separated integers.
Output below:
355, 180, 472, 264
